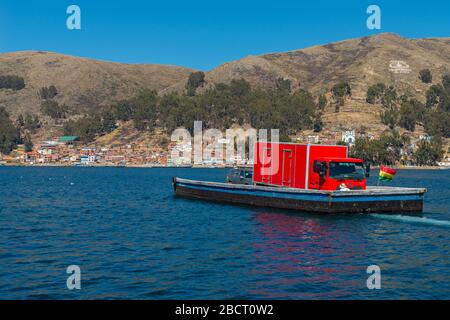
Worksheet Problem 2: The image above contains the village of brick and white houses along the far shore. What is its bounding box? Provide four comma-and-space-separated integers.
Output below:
0, 102, 450, 167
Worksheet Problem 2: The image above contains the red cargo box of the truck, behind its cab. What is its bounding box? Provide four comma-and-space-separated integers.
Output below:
253, 142, 348, 189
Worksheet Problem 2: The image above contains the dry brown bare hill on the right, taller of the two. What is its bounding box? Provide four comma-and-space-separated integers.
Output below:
165, 33, 450, 98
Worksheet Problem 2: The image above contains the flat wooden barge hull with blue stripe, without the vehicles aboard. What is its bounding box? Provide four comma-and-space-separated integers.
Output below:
173, 178, 427, 214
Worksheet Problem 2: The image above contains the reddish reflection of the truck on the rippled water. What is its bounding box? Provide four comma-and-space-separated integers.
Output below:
252, 212, 365, 298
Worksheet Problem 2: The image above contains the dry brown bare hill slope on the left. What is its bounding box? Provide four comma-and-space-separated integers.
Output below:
0, 51, 193, 114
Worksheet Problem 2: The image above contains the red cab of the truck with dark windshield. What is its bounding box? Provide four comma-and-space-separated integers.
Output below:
309, 158, 369, 190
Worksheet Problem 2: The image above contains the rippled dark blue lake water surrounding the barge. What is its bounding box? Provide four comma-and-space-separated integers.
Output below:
0, 167, 450, 299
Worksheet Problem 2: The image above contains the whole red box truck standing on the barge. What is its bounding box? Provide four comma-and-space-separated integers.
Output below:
253, 142, 369, 190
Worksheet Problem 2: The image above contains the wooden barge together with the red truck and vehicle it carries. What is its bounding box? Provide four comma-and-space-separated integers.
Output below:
173, 142, 427, 214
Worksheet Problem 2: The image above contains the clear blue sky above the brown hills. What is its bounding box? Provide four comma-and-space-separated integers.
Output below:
0, 0, 450, 70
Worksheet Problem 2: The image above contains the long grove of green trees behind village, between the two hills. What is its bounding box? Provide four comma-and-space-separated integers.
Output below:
58, 79, 323, 145
